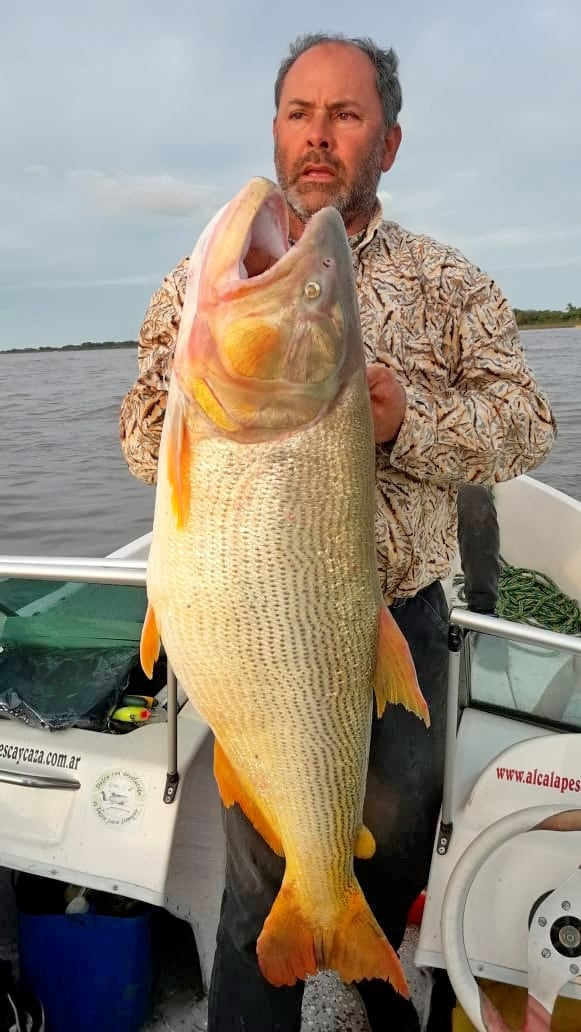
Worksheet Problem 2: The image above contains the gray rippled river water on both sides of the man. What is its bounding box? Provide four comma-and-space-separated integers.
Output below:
0, 329, 581, 555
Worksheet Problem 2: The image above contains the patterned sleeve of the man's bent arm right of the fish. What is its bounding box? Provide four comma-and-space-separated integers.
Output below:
372, 265, 556, 484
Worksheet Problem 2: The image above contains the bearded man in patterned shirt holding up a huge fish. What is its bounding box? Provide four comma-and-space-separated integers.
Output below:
121, 35, 554, 1032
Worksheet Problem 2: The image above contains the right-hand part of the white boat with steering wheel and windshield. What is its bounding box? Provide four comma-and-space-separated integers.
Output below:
421, 477, 581, 1032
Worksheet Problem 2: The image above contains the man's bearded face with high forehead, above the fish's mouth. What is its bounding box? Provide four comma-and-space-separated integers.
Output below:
273, 43, 401, 232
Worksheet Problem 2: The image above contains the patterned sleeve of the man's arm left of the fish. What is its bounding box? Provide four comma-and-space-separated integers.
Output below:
119, 258, 189, 484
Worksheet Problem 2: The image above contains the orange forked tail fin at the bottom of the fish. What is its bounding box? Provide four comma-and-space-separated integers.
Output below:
257, 876, 410, 998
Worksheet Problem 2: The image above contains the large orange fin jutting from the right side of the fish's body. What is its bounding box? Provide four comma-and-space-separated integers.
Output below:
374, 606, 429, 728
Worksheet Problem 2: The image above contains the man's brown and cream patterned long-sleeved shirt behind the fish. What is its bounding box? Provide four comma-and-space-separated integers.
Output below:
120, 204, 556, 599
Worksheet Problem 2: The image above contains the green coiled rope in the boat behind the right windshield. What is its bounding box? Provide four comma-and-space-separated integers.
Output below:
496, 560, 581, 635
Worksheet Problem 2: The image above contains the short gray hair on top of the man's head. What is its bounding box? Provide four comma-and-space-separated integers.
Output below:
275, 32, 401, 128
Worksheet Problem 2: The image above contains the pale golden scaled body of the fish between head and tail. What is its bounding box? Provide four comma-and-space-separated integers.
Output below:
150, 375, 381, 899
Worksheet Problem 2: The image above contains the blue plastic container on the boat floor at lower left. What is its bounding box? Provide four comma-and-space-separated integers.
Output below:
19, 911, 152, 1032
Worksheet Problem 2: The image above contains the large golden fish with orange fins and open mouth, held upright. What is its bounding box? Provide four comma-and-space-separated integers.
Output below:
141, 179, 428, 993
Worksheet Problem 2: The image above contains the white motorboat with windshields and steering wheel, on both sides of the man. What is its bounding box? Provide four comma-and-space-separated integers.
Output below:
0, 477, 581, 1030
